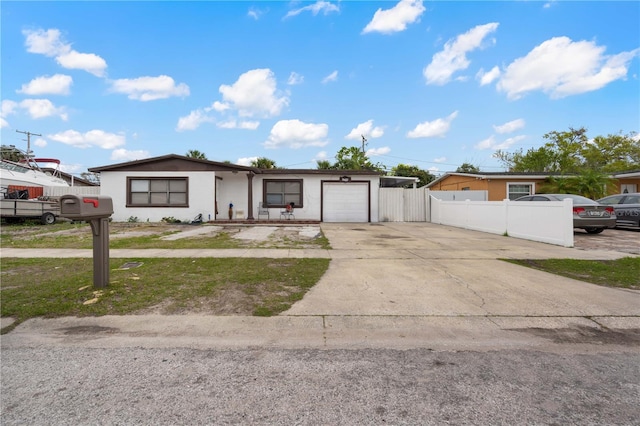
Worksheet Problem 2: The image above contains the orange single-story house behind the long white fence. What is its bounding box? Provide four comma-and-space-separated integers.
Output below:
426, 170, 640, 201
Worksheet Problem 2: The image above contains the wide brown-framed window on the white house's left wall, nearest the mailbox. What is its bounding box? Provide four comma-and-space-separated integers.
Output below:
127, 178, 189, 207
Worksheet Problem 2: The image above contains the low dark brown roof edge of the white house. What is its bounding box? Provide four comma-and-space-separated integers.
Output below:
89, 154, 381, 176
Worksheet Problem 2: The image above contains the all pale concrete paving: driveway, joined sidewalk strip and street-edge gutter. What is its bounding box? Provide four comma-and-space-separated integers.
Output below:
0, 223, 640, 351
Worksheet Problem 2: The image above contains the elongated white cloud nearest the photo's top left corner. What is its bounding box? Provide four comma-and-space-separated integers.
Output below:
22, 29, 107, 77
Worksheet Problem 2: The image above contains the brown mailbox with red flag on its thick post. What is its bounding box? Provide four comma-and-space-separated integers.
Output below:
60, 194, 113, 288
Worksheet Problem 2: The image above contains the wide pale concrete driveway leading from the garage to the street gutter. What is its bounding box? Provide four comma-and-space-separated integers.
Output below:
282, 223, 640, 317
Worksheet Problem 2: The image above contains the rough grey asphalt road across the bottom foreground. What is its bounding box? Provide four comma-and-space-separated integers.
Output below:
1, 348, 640, 426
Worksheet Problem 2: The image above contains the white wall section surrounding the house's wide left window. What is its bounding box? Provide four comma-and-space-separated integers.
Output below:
100, 171, 218, 222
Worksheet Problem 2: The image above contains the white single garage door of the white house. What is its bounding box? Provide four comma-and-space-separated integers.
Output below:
322, 182, 370, 222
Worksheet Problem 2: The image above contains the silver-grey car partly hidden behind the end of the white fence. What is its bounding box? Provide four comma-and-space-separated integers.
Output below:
515, 194, 616, 234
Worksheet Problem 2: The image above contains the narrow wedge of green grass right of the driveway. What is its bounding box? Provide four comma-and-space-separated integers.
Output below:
502, 257, 640, 289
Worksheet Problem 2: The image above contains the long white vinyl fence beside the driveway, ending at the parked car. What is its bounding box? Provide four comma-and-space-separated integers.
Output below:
430, 197, 573, 247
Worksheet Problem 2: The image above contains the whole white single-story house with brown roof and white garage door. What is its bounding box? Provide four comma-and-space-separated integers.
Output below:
89, 154, 380, 222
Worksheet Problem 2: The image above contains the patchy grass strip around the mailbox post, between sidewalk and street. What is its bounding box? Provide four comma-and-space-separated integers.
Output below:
0, 258, 329, 334
